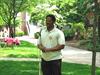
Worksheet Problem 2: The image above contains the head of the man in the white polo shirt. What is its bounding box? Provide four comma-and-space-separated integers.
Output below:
46, 14, 56, 28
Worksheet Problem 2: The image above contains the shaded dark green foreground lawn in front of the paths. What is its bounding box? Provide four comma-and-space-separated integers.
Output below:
0, 61, 100, 75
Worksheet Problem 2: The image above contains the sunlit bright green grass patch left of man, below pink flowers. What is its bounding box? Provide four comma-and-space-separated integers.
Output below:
0, 41, 39, 58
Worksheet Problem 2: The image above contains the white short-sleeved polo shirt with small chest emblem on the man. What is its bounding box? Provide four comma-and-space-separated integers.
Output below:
38, 27, 65, 61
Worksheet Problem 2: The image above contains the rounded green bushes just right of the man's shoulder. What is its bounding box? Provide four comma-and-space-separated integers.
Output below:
63, 23, 85, 38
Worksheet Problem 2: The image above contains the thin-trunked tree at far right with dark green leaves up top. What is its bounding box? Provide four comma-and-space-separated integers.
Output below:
78, 0, 99, 75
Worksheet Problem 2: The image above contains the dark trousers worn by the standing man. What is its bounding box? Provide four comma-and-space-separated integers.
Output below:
41, 59, 62, 75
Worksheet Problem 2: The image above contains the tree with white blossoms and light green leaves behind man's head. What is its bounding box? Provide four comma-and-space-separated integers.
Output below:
31, 0, 78, 27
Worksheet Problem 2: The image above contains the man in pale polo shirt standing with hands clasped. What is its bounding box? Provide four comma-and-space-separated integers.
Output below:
38, 14, 65, 75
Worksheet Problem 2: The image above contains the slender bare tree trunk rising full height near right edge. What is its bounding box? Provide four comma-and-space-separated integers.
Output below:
91, 0, 98, 75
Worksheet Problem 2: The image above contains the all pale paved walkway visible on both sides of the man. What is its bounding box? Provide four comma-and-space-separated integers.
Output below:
0, 36, 100, 67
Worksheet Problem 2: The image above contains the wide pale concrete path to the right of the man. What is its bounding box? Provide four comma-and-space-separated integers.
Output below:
62, 46, 100, 67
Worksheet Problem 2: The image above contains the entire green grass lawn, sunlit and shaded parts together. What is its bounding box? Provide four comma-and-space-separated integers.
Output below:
0, 41, 100, 75
